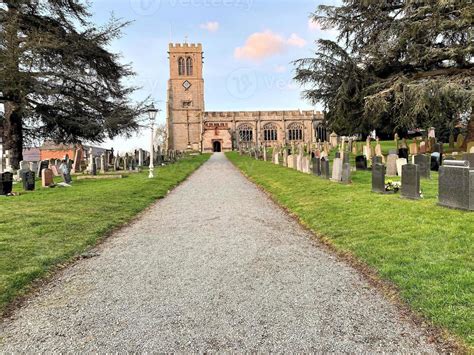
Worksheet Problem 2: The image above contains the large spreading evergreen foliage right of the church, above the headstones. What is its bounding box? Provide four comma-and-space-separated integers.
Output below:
296, 0, 474, 140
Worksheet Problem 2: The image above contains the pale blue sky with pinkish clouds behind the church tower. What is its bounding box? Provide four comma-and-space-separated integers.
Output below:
91, 0, 338, 150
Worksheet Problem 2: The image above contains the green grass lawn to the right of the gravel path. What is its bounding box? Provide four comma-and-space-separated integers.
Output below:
227, 152, 474, 349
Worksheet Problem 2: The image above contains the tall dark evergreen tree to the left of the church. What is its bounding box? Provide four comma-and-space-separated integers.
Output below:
0, 0, 144, 167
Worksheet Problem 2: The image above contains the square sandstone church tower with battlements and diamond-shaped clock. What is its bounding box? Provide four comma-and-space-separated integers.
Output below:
167, 43, 204, 151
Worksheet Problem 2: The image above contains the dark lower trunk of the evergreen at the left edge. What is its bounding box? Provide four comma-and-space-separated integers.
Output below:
3, 102, 23, 169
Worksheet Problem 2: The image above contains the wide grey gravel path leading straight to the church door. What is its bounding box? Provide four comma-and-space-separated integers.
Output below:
0, 154, 436, 352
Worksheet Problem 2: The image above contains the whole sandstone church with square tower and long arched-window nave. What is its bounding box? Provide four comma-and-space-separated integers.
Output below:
167, 43, 327, 153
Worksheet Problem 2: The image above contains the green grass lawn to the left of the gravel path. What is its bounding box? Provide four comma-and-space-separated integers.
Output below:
0, 155, 209, 313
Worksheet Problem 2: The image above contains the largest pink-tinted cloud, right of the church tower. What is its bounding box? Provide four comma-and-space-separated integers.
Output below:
234, 30, 306, 60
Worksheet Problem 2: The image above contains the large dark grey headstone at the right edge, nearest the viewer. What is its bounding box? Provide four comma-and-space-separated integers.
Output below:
438, 160, 474, 211
